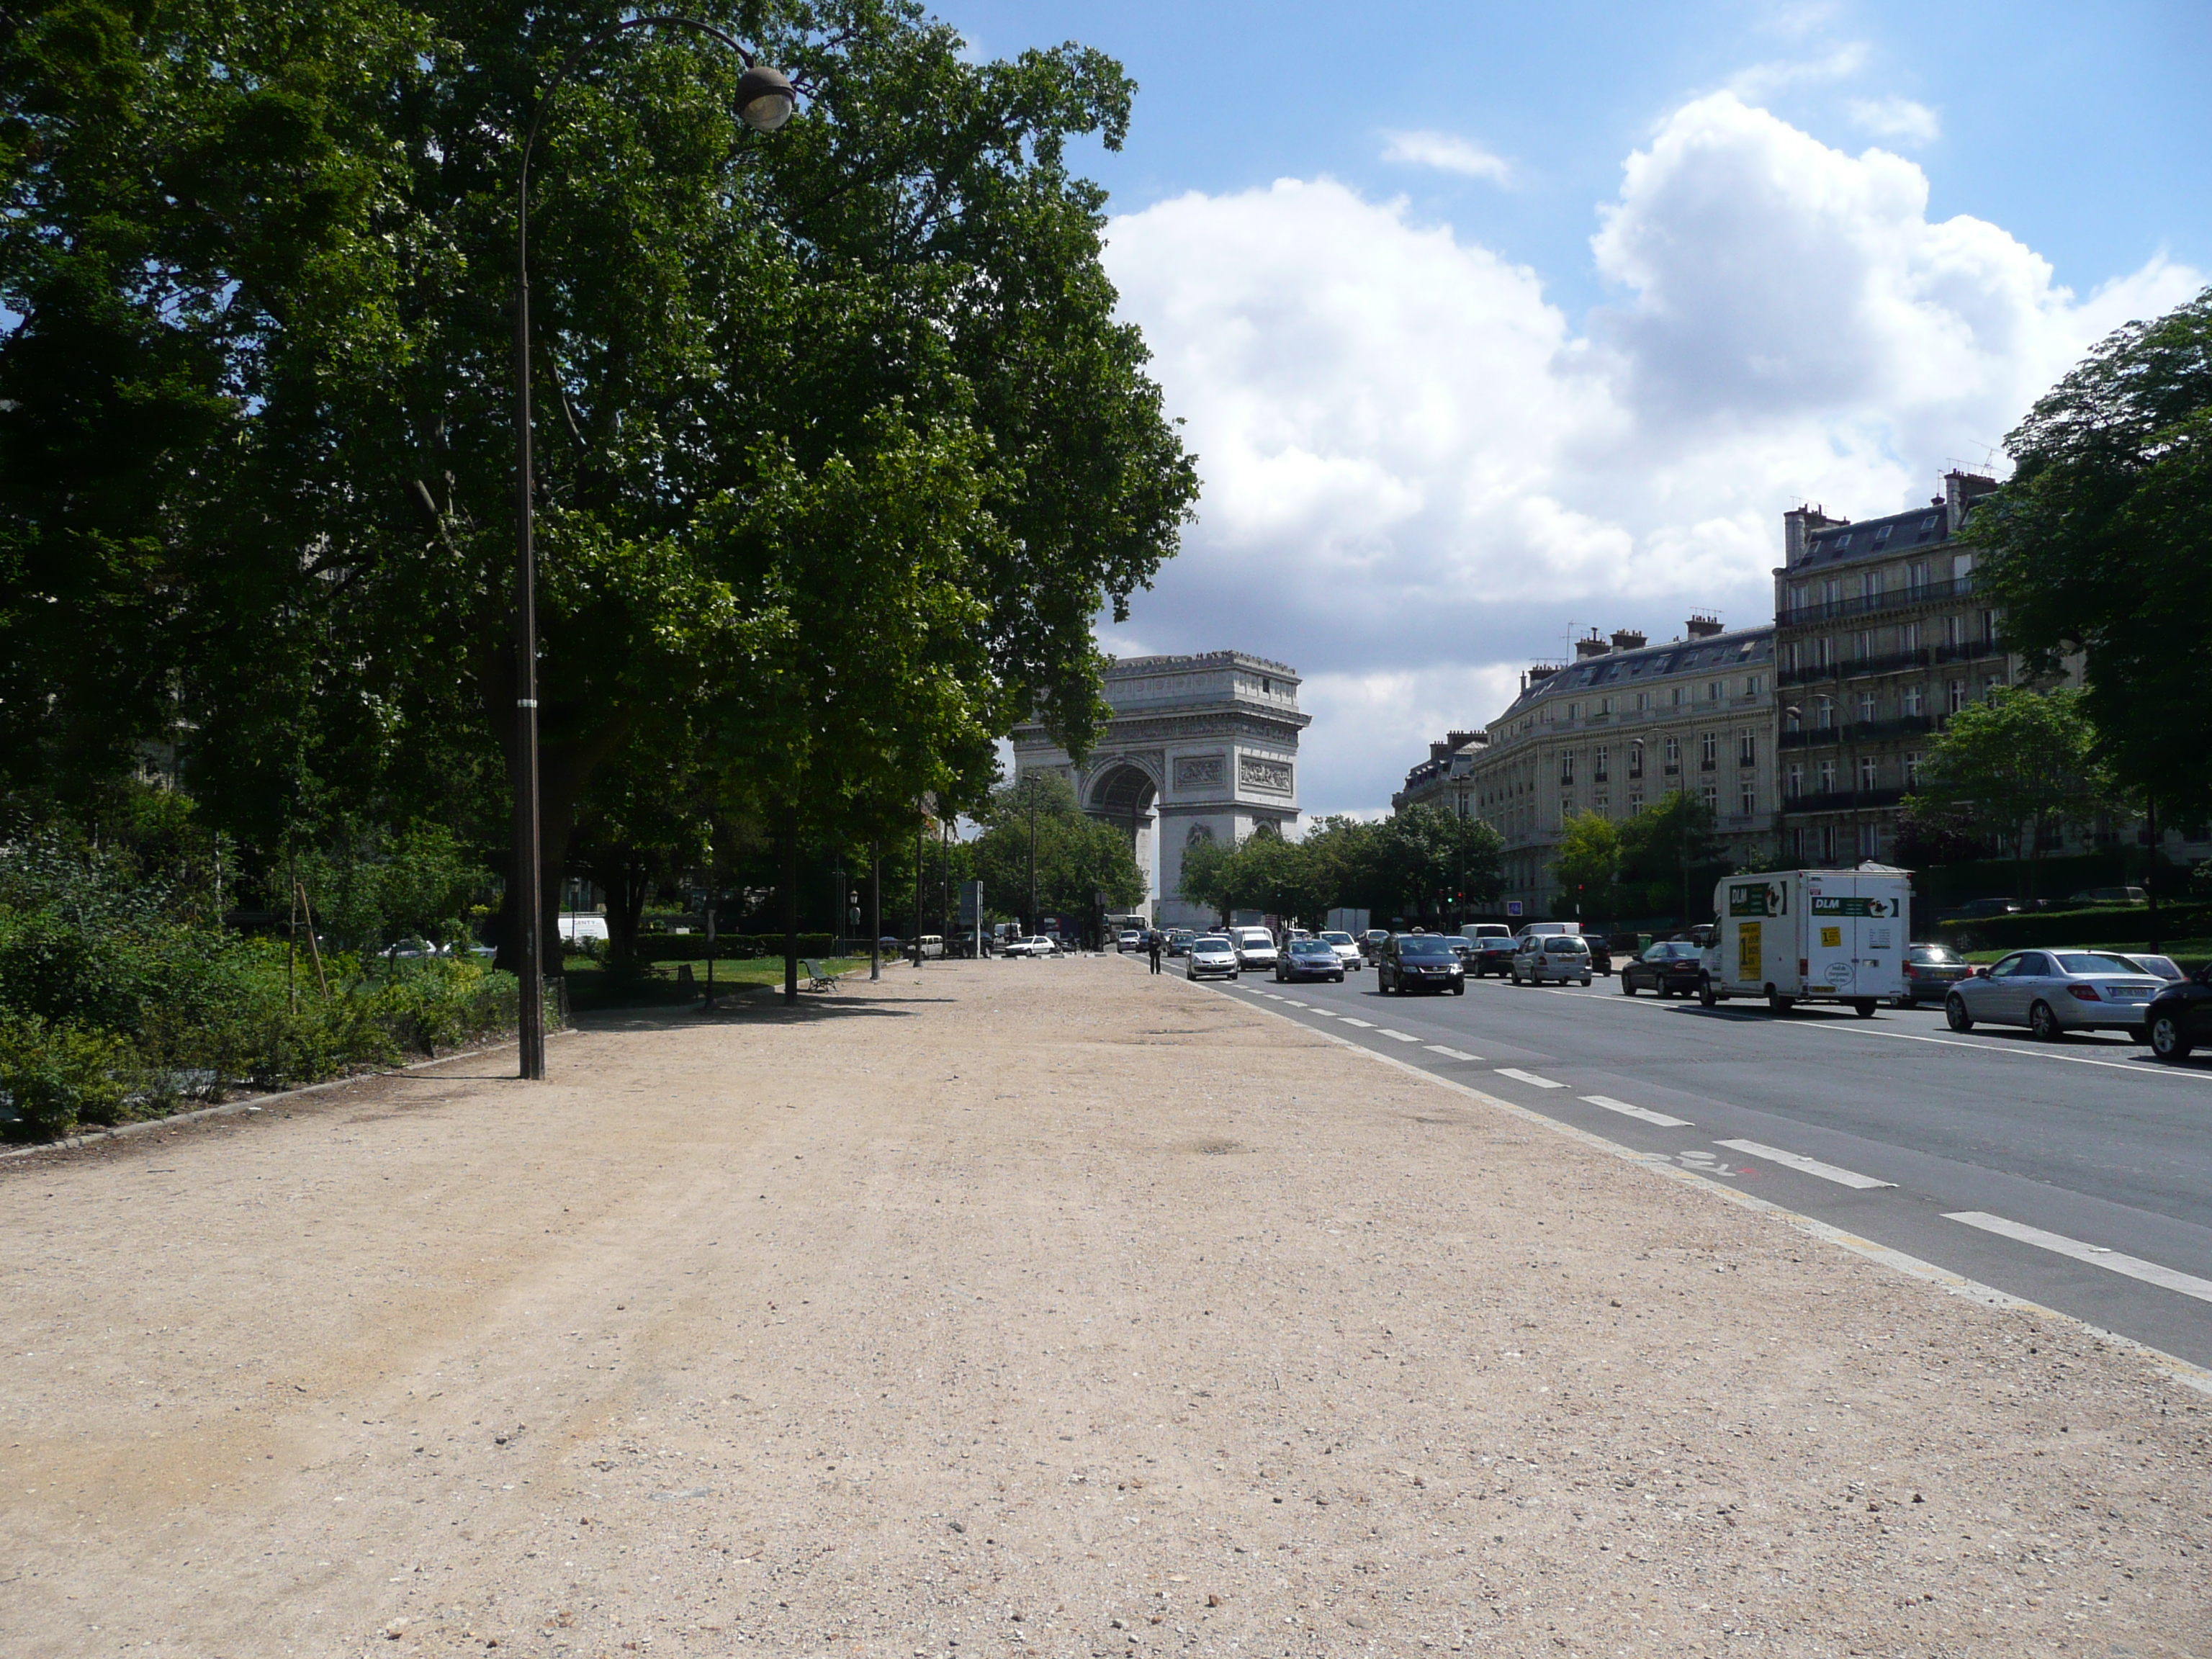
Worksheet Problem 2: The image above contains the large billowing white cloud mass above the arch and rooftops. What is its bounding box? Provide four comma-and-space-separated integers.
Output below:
1108, 93, 2203, 811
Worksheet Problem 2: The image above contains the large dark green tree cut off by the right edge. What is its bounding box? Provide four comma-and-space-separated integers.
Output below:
1966, 289, 2212, 827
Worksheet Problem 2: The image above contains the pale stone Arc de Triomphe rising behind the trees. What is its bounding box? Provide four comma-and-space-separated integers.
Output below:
1013, 650, 1312, 927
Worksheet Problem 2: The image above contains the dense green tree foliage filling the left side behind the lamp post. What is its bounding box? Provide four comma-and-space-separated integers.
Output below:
0, 0, 1197, 973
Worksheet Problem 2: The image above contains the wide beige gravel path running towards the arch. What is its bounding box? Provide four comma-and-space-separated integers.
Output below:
0, 958, 2212, 1659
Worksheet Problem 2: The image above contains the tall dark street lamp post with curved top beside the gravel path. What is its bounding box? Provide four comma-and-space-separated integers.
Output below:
513, 29, 799, 1079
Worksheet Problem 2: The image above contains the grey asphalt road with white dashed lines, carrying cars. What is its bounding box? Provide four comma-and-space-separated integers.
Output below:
1223, 969, 2212, 1364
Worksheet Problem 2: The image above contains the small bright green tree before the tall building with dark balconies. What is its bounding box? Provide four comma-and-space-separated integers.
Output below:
1909, 685, 2113, 891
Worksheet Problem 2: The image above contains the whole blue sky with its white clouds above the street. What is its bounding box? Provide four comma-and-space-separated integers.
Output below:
938, 0, 2212, 811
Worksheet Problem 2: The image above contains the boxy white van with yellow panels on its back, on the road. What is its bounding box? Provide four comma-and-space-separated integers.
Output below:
1699, 867, 1913, 1017
